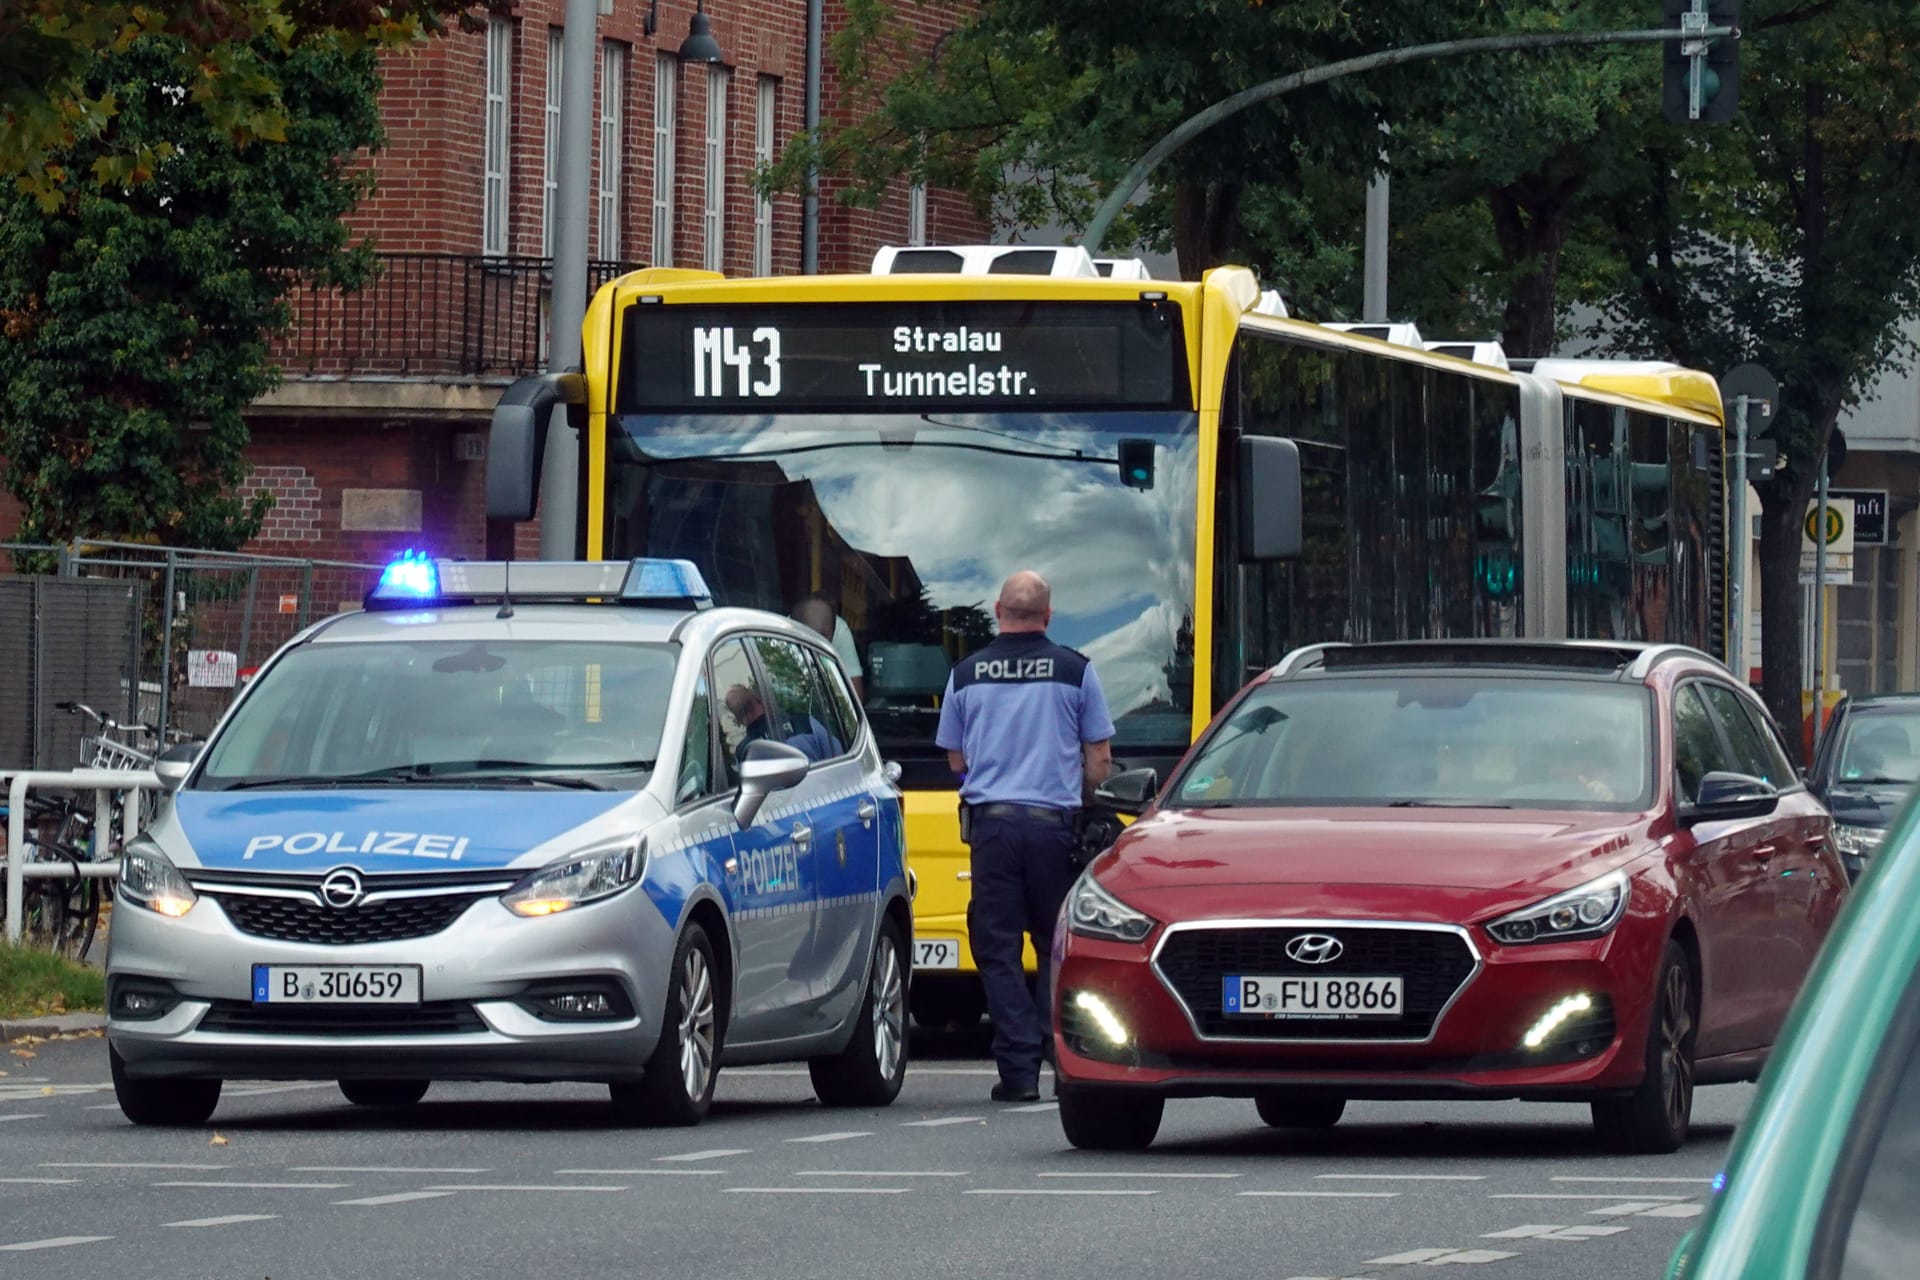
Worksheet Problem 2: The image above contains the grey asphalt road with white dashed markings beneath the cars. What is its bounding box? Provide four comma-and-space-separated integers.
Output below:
0, 1036, 1751, 1280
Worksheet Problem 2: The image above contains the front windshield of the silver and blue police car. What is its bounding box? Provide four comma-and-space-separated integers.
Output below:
194, 639, 676, 791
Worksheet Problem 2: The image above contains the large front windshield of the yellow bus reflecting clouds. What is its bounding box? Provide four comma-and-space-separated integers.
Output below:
605, 411, 1200, 771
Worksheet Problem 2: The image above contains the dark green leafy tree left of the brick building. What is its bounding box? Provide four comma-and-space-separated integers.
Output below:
0, 36, 380, 547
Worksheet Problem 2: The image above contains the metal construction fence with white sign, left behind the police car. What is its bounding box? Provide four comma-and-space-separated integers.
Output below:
0, 541, 380, 770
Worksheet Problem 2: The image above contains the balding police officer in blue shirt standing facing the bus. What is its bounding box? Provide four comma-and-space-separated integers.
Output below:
935, 570, 1114, 1102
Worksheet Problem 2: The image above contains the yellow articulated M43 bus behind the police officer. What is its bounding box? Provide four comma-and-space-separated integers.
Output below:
488, 246, 1726, 1025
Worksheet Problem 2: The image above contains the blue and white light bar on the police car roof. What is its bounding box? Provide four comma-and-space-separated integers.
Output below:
367, 551, 712, 608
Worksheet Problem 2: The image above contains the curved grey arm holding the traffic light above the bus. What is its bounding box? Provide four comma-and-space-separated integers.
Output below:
1081, 27, 1740, 253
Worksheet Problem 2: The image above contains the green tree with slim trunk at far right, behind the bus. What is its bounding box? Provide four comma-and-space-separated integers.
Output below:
1599, 0, 1920, 744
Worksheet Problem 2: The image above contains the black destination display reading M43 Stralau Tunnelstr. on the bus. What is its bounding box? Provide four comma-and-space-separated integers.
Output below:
614, 301, 1188, 413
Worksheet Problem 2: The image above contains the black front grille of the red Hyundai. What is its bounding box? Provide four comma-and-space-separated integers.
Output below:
1154, 925, 1478, 1040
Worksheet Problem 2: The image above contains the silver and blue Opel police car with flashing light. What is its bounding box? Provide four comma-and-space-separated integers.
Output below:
108, 555, 912, 1125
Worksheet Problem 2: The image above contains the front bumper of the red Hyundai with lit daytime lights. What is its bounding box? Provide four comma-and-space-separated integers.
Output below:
1054, 917, 1659, 1100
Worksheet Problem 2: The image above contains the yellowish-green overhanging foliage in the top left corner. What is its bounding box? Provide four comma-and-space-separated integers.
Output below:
0, 0, 495, 209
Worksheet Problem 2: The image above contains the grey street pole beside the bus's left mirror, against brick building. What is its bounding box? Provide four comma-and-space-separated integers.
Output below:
540, 0, 599, 560
